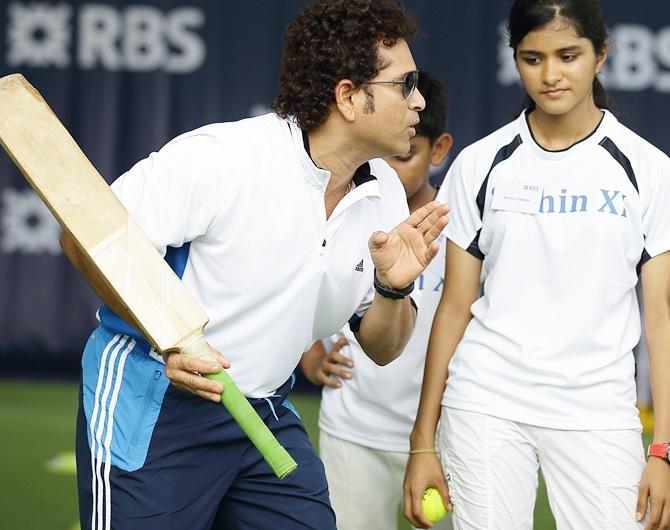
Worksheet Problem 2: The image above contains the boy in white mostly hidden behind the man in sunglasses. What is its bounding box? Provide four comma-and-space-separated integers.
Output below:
301, 72, 453, 530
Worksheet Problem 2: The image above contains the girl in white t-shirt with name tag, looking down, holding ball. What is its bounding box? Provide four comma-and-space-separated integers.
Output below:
405, 0, 670, 530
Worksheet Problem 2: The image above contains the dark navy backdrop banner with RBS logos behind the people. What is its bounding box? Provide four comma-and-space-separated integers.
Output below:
0, 0, 670, 370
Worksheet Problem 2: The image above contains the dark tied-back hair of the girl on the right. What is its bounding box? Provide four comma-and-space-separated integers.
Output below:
507, 0, 611, 110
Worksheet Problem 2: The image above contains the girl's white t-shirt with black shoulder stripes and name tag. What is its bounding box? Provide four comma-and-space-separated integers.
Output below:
442, 111, 670, 430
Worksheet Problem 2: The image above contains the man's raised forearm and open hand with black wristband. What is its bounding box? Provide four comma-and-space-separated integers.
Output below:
356, 201, 448, 365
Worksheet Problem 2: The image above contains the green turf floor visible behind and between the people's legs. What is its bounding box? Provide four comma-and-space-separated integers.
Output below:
0, 379, 652, 530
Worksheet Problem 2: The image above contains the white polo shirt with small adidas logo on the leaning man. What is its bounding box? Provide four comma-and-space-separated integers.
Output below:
101, 114, 408, 397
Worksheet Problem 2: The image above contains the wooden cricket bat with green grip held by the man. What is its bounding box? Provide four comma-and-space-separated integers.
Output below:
0, 74, 297, 478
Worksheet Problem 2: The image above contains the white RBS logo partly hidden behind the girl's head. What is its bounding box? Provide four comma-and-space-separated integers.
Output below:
498, 24, 670, 93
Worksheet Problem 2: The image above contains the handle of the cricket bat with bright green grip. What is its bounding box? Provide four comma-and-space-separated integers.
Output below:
180, 335, 298, 479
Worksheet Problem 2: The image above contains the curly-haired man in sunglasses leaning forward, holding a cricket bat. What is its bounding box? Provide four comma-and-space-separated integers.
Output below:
63, 0, 447, 530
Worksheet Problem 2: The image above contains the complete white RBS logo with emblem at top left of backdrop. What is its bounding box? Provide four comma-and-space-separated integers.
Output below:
6, 2, 206, 74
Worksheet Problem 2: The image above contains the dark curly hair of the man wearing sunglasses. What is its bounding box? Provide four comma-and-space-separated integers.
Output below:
272, 0, 416, 131
